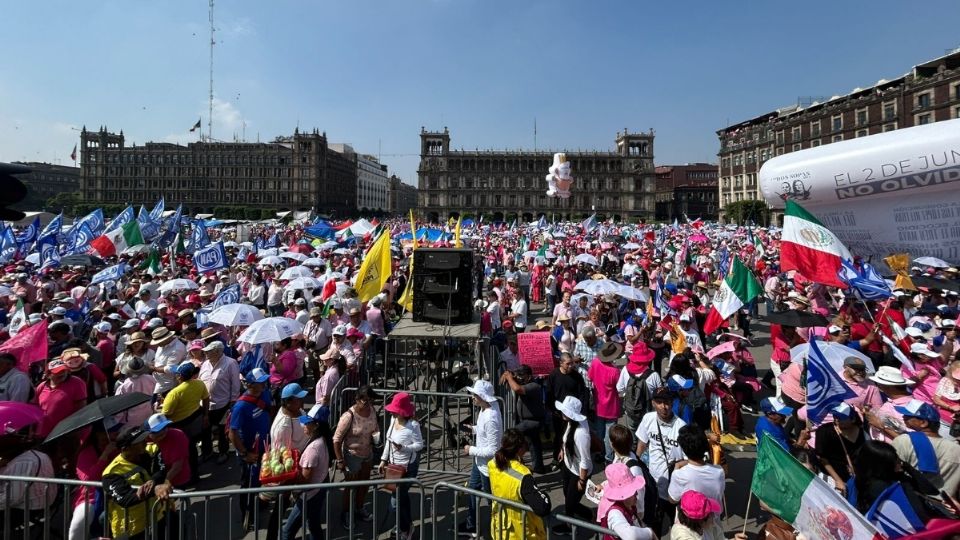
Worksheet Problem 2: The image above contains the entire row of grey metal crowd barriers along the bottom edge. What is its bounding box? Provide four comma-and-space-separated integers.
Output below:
0, 470, 618, 540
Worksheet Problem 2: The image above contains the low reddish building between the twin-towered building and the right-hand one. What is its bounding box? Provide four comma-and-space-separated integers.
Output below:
654, 163, 720, 221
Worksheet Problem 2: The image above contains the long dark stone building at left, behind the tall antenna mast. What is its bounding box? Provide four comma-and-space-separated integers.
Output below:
80, 128, 357, 216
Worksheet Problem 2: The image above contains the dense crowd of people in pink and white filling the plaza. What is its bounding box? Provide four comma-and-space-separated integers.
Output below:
0, 213, 960, 539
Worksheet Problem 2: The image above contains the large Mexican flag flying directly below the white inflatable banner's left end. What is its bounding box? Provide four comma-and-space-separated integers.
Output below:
780, 200, 853, 289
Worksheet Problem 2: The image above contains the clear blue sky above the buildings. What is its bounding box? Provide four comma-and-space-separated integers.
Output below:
0, 0, 960, 183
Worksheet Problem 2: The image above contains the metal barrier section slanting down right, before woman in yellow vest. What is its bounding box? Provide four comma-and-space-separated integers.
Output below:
430, 482, 619, 540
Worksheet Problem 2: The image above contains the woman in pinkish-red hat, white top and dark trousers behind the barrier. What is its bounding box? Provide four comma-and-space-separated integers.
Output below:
378, 392, 423, 540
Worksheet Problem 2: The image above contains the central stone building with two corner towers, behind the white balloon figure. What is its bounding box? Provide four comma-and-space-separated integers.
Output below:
417, 128, 655, 221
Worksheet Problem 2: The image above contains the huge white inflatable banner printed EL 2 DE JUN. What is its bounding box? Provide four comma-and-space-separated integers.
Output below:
759, 120, 960, 265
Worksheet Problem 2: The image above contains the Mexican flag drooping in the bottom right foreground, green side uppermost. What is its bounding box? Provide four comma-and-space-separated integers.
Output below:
750, 435, 883, 540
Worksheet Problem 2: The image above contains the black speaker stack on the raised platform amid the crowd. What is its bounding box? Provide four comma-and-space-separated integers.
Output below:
413, 248, 473, 324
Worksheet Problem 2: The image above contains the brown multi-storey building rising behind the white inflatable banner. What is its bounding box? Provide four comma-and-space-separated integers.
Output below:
717, 50, 960, 224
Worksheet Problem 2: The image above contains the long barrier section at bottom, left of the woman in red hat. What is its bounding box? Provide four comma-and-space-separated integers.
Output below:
147, 478, 428, 540
